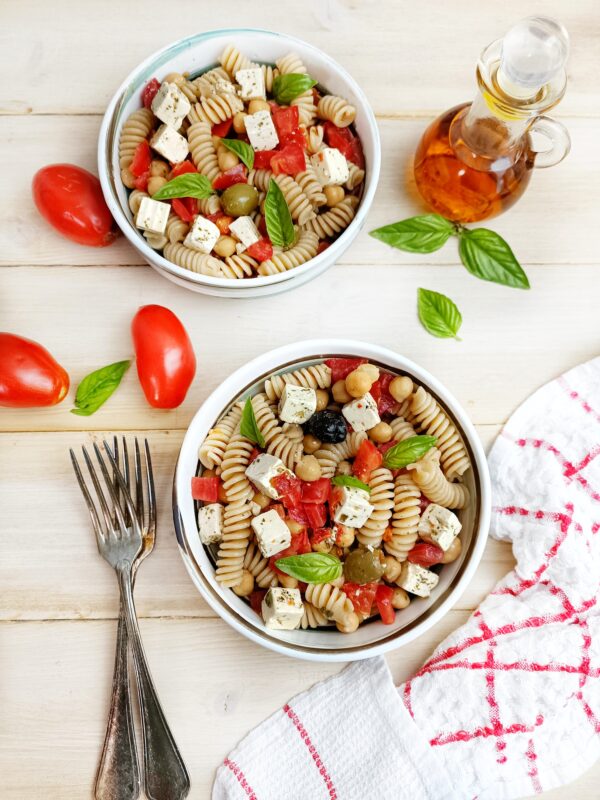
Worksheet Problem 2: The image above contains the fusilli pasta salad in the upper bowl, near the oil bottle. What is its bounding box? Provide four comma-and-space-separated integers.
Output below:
119, 45, 365, 279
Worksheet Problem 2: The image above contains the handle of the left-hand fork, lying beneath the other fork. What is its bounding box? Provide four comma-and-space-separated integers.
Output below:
94, 602, 140, 800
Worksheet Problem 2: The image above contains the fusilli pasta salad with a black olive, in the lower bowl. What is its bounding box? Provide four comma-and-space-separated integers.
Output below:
191, 358, 471, 633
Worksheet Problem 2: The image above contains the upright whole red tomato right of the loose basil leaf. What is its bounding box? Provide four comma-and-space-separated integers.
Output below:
131, 306, 196, 408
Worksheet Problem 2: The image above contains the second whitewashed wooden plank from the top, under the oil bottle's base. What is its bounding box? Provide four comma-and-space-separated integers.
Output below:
0, 114, 600, 272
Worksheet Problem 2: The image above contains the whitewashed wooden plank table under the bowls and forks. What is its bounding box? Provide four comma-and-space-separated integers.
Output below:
0, 0, 600, 800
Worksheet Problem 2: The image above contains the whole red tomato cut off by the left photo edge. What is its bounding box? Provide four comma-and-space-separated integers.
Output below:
0, 333, 69, 408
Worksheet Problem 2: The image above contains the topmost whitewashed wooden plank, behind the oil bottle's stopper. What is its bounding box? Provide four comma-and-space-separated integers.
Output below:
0, 0, 599, 115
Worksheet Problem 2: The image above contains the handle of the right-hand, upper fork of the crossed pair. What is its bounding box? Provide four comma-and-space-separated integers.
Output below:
117, 562, 190, 800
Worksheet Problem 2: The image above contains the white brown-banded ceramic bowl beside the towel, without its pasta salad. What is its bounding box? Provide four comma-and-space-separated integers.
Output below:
173, 339, 491, 661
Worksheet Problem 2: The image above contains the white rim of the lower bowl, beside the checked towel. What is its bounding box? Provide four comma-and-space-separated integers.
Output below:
173, 339, 491, 662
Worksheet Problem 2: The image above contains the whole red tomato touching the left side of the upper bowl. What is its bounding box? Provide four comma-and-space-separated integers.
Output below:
32, 164, 117, 247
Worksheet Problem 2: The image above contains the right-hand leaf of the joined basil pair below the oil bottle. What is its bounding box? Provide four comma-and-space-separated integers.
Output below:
459, 228, 529, 289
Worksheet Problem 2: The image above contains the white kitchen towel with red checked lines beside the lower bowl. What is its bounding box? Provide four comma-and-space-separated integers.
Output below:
213, 358, 600, 800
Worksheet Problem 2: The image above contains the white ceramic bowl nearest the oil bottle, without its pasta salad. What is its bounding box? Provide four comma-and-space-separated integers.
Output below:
98, 28, 381, 297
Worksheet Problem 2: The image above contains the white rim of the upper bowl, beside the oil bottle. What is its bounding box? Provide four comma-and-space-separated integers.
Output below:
98, 28, 381, 289
